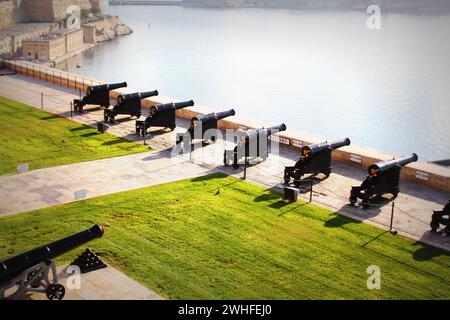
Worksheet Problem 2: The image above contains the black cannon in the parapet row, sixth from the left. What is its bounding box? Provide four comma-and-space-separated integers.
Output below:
284, 138, 351, 187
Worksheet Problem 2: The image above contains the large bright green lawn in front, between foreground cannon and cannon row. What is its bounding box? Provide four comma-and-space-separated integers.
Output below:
0, 174, 450, 299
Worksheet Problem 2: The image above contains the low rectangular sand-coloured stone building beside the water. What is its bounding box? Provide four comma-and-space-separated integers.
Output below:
22, 29, 84, 61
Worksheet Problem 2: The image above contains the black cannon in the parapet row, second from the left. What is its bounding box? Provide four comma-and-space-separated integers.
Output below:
104, 90, 158, 122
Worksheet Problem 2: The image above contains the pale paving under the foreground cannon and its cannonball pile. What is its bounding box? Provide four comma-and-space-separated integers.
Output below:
22, 265, 163, 300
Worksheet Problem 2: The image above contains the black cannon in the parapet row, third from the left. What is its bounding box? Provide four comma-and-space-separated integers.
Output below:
136, 100, 194, 136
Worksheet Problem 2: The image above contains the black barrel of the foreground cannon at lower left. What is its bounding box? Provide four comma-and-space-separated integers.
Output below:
0, 224, 104, 283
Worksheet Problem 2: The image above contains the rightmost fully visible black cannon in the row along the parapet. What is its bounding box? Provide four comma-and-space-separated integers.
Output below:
349, 153, 418, 208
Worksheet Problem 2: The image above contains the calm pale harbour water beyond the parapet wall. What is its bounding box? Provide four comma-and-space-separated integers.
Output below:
67, 6, 450, 160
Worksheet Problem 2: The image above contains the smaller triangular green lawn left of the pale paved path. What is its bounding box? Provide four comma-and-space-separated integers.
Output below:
0, 97, 149, 175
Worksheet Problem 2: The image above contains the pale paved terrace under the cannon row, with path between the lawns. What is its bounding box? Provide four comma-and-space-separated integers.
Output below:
0, 75, 450, 250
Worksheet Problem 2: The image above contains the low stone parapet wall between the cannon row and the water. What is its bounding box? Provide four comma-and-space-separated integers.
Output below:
3, 61, 450, 192
